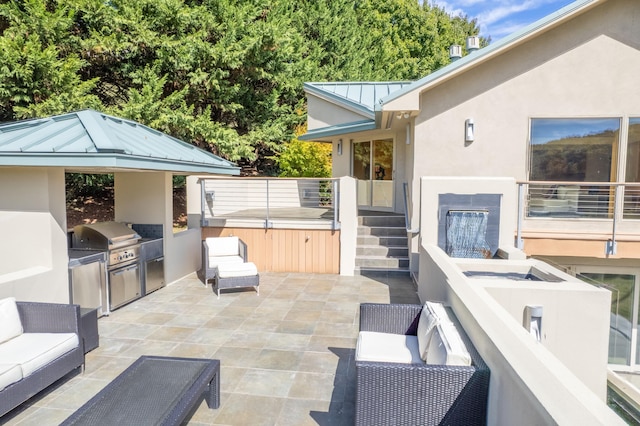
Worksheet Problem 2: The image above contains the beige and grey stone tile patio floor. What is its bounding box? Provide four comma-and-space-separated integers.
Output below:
0, 273, 419, 426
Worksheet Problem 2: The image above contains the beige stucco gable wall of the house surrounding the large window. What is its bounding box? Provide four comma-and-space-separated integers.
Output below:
406, 0, 640, 258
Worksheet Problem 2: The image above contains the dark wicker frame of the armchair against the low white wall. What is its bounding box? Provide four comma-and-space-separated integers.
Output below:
355, 303, 489, 426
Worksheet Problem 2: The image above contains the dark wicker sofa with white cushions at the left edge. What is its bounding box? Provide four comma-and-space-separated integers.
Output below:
0, 298, 84, 416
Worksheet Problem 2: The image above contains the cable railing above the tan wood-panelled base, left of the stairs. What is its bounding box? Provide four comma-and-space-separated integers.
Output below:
200, 178, 340, 229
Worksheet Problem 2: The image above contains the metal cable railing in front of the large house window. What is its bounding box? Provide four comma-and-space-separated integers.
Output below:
517, 181, 640, 254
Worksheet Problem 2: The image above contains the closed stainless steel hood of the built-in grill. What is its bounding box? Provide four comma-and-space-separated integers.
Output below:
73, 222, 141, 250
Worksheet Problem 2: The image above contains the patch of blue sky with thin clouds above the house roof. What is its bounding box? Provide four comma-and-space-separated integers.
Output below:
425, 0, 574, 42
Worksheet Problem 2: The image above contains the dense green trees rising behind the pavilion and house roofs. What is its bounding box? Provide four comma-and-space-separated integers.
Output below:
0, 0, 486, 173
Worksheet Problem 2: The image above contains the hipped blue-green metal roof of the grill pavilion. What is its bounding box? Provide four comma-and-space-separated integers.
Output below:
0, 110, 240, 175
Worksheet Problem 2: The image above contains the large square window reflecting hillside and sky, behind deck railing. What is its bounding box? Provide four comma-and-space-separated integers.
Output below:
528, 118, 621, 218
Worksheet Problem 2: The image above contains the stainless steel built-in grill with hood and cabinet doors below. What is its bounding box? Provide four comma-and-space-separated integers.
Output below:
73, 222, 142, 310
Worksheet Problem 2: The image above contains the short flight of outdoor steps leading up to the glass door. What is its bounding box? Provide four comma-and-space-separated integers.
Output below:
355, 211, 409, 275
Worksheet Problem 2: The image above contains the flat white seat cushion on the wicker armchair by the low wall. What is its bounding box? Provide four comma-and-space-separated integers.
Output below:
356, 331, 423, 364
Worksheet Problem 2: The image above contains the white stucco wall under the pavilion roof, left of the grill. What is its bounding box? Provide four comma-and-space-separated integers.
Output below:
0, 168, 69, 303
